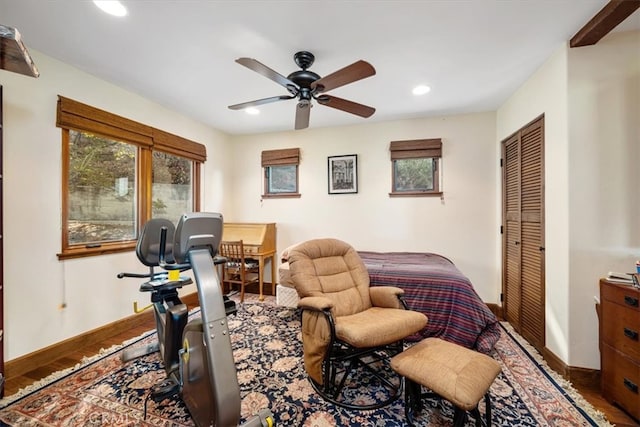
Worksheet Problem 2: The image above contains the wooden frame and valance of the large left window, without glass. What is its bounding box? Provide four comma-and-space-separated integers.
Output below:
56, 95, 207, 260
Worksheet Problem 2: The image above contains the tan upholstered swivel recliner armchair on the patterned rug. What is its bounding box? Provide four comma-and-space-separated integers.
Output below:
289, 239, 427, 409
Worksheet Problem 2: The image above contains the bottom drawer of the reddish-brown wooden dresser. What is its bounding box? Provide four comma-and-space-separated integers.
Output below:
601, 344, 640, 419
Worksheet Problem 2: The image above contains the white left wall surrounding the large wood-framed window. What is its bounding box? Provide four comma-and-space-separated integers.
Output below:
0, 51, 231, 360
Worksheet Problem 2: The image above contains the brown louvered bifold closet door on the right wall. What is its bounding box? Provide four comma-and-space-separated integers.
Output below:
503, 117, 545, 350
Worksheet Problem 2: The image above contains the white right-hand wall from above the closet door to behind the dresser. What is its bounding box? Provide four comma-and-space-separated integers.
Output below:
496, 31, 640, 369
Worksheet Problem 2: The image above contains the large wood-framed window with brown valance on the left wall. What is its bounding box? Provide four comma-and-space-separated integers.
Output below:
57, 97, 206, 258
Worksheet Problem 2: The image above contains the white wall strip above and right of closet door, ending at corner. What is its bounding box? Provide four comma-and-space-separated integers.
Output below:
496, 46, 569, 361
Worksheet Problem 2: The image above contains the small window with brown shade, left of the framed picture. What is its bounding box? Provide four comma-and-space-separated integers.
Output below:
262, 148, 300, 198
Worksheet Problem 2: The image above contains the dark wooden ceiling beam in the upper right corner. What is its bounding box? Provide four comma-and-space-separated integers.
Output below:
569, 0, 640, 47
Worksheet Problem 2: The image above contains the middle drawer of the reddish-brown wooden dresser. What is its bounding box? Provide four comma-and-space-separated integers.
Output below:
601, 301, 640, 360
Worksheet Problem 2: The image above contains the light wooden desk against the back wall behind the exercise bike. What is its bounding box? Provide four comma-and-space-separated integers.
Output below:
222, 222, 277, 301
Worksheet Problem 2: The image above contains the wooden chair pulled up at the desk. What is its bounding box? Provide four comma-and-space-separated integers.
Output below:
219, 240, 260, 302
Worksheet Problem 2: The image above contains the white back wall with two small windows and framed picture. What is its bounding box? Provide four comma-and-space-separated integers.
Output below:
227, 112, 500, 303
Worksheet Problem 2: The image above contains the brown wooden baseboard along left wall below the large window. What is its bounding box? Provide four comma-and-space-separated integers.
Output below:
4, 292, 198, 379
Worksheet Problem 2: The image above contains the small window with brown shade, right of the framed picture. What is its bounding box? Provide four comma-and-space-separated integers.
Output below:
389, 139, 442, 196
